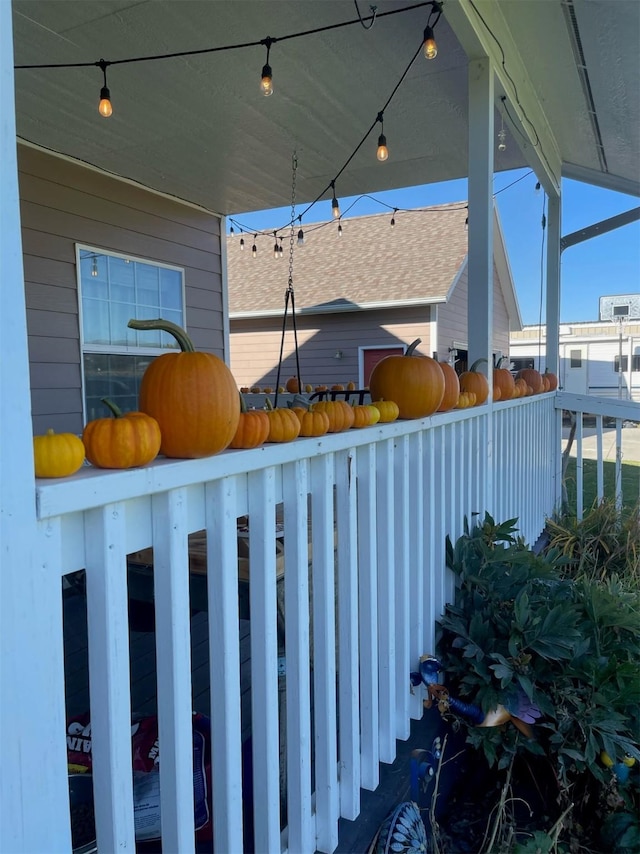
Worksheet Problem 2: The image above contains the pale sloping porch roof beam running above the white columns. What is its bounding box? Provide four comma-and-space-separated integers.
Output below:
443, 0, 562, 196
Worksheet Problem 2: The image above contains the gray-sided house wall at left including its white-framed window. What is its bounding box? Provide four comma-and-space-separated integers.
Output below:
18, 144, 224, 433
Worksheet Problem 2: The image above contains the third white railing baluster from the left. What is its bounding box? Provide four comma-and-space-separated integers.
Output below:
205, 477, 244, 851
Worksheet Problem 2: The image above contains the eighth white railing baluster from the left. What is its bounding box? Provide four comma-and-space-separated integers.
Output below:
357, 445, 380, 790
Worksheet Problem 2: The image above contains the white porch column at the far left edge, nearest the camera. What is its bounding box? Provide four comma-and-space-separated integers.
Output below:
0, 0, 71, 854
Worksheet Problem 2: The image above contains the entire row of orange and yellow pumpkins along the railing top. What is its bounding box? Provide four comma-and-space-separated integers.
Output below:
34, 319, 557, 477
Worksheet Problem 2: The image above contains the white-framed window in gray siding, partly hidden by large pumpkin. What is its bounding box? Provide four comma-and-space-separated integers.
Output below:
76, 246, 184, 421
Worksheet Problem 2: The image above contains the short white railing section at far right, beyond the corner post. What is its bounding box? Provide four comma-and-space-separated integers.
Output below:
555, 392, 640, 519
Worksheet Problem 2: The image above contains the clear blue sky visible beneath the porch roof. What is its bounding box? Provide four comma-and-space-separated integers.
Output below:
228, 169, 640, 323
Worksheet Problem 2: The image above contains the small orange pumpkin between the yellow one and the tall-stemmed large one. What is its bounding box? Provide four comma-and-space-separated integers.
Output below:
82, 397, 161, 469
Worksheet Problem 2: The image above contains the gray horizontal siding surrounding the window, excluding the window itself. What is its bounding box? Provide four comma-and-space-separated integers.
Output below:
18, 145, 224, 433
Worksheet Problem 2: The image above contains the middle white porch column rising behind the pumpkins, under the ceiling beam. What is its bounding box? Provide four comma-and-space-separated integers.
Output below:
467, 57, 494, 385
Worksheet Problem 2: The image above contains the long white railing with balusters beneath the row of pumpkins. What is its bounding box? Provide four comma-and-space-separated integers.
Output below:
32, 394, 559, 854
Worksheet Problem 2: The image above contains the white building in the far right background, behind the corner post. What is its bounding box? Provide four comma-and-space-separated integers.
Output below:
509, 321, 640, 401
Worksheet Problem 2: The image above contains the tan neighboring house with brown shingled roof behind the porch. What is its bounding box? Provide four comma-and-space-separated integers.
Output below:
227, 202, 521, 387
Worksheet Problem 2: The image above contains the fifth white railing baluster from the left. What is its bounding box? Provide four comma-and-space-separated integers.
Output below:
283, 460, 316, 852
